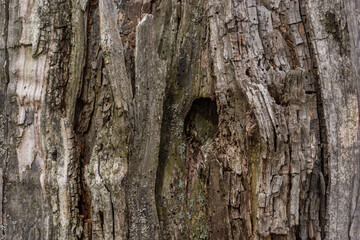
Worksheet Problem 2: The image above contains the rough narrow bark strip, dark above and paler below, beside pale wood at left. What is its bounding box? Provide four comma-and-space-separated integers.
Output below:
42, 1, 76, 236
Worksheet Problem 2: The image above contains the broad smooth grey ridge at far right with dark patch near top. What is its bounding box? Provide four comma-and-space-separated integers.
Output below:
305, 2, 359, 239
